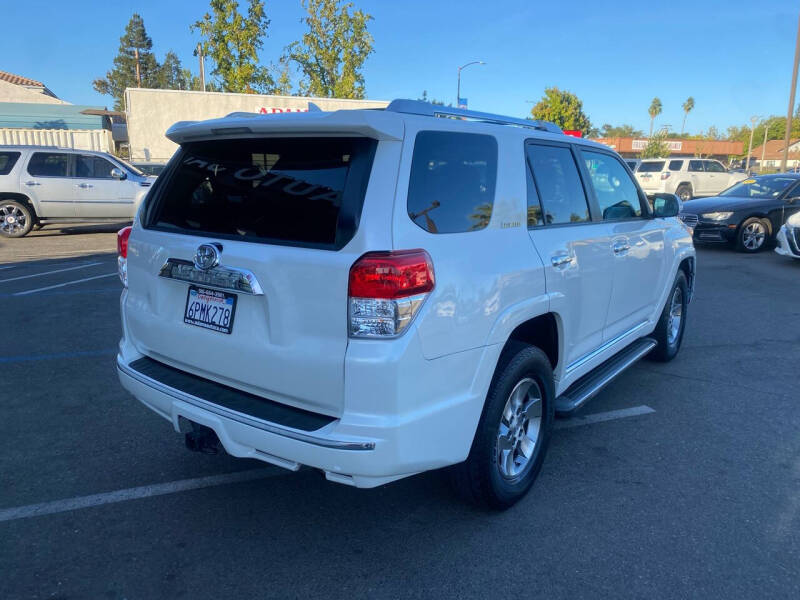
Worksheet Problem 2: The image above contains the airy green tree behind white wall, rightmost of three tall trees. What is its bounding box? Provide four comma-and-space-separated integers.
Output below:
284, 0, 373, 98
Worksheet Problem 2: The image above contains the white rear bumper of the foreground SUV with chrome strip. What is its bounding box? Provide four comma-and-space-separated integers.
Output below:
117, 343, 491, 488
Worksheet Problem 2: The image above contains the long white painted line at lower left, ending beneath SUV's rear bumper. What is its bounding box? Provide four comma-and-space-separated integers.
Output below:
0, 467, 283, 523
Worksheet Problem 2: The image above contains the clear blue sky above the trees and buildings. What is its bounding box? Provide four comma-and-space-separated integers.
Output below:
0, 0, 798, 132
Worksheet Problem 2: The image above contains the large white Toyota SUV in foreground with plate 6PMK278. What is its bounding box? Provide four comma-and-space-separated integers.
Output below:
112, 100, 695, 508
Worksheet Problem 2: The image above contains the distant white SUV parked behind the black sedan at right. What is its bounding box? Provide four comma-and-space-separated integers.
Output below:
636, 158, 747, 202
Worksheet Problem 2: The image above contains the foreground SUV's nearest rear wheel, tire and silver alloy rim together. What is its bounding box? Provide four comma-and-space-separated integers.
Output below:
451, 343, 555, 510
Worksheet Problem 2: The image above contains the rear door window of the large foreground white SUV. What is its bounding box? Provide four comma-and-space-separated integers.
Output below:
527, 144, 589, 225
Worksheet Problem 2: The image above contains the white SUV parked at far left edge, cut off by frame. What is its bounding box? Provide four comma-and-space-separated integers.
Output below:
0, 146, 155, 237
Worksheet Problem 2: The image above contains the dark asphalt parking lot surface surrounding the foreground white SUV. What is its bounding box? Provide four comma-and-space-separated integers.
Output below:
0, 227, 800, 599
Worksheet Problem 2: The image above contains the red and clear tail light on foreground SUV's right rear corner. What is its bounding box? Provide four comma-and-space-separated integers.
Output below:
347, 250, 434, 338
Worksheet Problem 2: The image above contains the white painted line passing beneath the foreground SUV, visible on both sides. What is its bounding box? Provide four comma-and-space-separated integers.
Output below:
0, 405, 656, 523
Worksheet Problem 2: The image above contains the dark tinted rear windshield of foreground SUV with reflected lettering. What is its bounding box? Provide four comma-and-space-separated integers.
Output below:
146, 137, 377, 250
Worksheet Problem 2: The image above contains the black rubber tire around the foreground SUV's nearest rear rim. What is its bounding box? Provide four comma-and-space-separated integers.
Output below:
450, 343, 555, 510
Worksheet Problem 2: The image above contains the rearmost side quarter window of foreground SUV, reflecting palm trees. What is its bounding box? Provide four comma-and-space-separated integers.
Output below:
408, 131, 497, 233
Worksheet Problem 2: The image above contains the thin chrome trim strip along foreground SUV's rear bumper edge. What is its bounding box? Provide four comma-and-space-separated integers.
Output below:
117, 356, 375, 450
